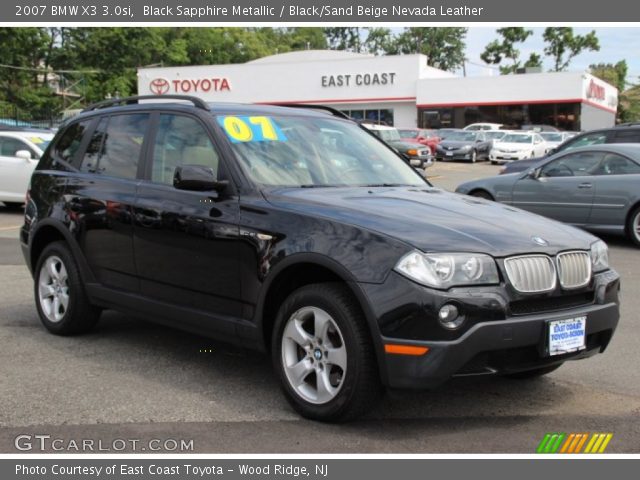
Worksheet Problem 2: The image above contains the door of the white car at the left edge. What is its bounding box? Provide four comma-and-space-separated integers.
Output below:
0, 135, 39, 202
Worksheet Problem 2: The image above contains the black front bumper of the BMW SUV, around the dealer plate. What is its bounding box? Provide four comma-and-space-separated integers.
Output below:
365, 270, 619, 389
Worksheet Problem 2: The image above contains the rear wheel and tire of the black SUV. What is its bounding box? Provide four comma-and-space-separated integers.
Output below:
34, 242, 100, 335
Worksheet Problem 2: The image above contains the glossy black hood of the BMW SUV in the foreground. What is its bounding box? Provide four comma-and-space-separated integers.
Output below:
264, 186, 596, 257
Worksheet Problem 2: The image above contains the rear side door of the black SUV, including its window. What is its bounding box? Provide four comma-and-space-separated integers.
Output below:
65, 112, 149, 292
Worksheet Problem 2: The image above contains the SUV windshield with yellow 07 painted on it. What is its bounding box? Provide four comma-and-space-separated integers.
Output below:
217, 115, 425, 187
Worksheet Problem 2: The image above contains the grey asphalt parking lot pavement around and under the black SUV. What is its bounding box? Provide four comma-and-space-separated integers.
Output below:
0, 169, 640, 453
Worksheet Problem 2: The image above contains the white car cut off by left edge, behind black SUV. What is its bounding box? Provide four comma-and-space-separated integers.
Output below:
0, 130, 53, 207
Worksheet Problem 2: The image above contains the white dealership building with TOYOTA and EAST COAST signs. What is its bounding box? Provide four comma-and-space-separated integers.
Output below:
138, 50, 618, 130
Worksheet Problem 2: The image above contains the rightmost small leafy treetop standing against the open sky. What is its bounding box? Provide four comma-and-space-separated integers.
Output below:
542, 27, 600, 72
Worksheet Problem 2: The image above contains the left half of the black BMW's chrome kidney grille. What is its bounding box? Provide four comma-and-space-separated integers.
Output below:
504, 255, 556, 293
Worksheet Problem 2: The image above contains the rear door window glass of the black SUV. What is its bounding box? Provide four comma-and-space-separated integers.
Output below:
81, 113, 149, 179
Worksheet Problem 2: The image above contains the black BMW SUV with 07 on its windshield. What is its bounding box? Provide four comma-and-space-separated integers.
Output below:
20, 95, 619, 421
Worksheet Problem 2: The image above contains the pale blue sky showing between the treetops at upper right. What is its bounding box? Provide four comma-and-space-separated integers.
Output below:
457, 27, 640, 84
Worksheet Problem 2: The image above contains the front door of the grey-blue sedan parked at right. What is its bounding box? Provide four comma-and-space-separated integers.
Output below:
512, 151, 602, 225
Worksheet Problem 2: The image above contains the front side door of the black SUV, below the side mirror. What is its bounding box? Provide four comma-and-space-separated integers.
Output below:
134, 112, 242, 326
